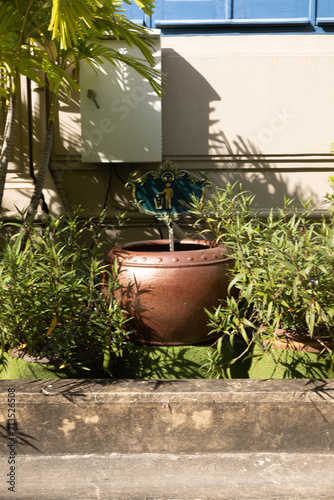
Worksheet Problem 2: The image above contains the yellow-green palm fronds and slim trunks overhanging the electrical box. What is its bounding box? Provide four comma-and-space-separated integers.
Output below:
0, 0, 162, 216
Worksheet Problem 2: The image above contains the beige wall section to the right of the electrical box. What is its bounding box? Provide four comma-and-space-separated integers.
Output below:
162, 35, 334, 210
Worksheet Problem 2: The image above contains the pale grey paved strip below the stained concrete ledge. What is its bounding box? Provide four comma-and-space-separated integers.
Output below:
0, 452, 334, 500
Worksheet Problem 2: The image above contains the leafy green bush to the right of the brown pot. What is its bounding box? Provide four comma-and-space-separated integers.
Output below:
193, 179, 334, 377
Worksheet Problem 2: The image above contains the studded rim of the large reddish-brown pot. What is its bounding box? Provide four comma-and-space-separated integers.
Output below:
108, 239, 231, 267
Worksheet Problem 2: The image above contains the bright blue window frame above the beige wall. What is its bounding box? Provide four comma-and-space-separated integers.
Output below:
124, 0, 334, 35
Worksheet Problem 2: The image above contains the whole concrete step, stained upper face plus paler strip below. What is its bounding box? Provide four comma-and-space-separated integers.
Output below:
0, 380, 334, 500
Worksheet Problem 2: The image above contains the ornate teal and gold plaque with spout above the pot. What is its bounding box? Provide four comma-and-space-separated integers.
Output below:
125, 160, 212, 252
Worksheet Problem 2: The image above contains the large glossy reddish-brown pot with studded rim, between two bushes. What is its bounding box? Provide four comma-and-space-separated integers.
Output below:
108, 240, 231, 345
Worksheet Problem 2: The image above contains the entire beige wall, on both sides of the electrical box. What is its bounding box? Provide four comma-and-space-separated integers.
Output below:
4, 35, 334, 239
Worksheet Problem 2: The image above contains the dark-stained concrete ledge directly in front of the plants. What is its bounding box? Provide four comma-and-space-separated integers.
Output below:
0, 380, 334, 457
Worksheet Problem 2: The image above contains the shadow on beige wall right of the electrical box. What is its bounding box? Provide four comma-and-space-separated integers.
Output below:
162, 49, 331, 210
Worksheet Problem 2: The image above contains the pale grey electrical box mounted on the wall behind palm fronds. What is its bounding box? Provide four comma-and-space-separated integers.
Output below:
80, 36, 162, 163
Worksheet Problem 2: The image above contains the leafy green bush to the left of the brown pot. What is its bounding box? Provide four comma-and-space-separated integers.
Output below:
0, 209, 127, 370
